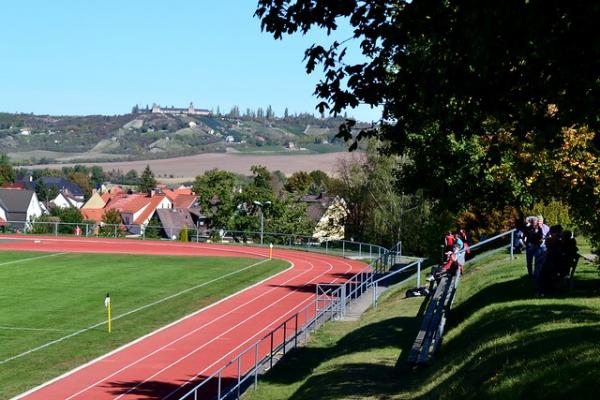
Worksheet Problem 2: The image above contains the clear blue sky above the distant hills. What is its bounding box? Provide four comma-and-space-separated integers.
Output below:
0, 0, 380, 121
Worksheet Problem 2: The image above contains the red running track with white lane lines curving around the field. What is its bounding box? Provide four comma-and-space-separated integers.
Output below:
0, 236, 364, 400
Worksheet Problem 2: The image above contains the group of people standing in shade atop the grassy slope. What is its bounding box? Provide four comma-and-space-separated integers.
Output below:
513, 215, 579, 295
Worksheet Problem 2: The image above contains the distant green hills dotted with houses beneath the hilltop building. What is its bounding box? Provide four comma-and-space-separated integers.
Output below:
0, 112, 370, 165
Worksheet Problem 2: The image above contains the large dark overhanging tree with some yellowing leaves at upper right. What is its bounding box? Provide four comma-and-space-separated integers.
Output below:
256, 0, 600, 253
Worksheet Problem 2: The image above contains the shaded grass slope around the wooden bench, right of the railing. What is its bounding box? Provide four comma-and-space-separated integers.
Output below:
245, 248, 600, 400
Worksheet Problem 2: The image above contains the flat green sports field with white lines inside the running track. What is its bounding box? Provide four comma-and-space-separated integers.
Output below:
0, 251, 289, 399
